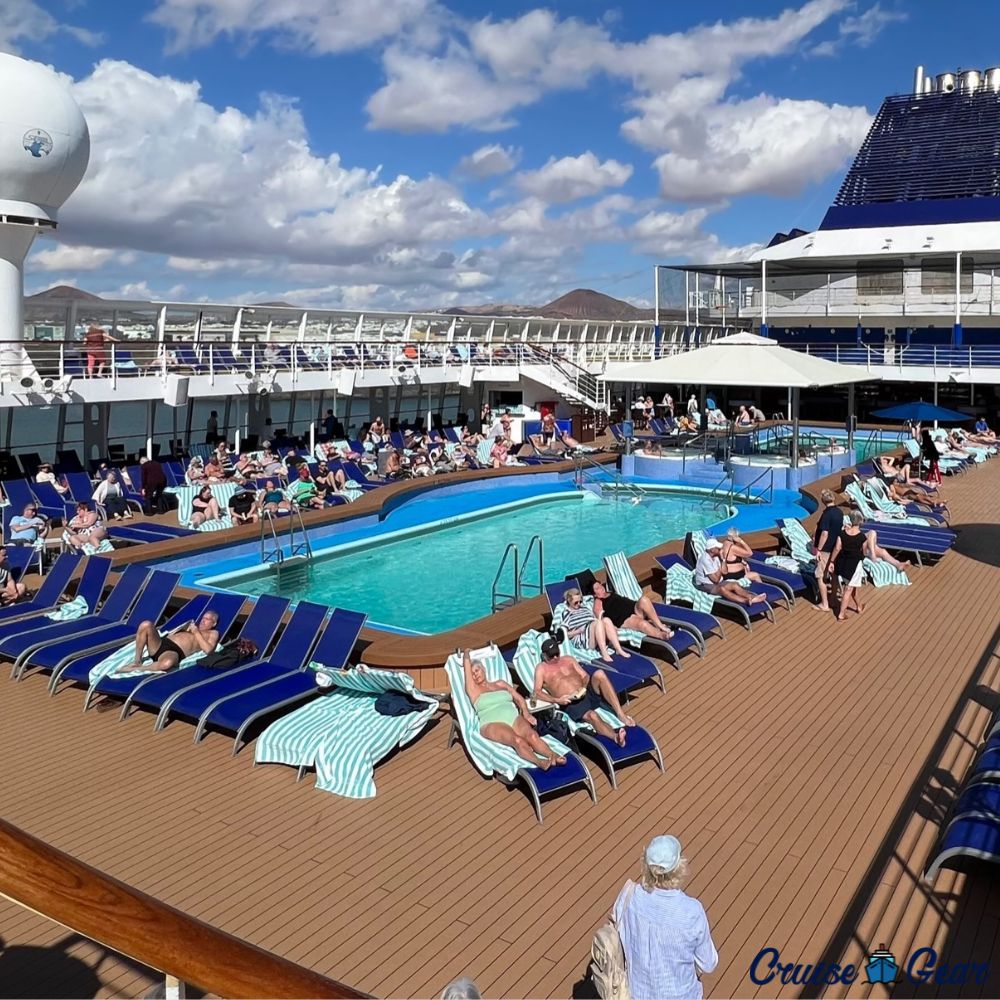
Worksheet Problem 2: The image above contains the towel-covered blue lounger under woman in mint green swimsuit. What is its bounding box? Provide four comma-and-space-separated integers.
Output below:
444, 646, 597, 823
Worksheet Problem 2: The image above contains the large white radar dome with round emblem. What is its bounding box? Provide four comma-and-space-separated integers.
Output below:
0, 52, 90, 222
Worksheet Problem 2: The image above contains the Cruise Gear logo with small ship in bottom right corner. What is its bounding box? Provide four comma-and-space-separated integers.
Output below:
750, 944, 990, 986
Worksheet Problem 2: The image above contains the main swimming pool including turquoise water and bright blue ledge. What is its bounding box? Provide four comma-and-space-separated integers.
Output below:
178, 479, 805, 633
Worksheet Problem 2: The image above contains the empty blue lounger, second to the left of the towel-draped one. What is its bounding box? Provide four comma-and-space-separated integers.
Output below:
156, 601, 327, 741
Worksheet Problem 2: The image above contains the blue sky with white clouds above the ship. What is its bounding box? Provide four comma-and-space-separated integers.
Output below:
0, 0, 976, 309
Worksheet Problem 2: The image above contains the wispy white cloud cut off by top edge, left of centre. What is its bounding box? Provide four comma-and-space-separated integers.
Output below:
149, 0, 435, 55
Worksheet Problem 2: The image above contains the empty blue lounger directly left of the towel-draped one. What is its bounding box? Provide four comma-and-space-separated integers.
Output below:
194, 605, 368, 756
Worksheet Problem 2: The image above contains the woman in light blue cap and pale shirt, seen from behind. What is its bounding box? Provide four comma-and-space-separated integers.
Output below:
614, 834, 719, 1000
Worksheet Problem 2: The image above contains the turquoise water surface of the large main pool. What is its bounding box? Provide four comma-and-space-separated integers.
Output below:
213, 491, 728, 633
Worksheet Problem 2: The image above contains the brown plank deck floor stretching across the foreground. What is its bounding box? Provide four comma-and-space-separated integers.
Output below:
0, 460, 1000, 997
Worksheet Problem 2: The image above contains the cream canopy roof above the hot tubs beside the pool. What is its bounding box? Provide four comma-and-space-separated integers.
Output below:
601, 333, 878, 389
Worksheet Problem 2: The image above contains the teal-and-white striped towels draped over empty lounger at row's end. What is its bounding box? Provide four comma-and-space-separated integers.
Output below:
254, 665, 439, 799
